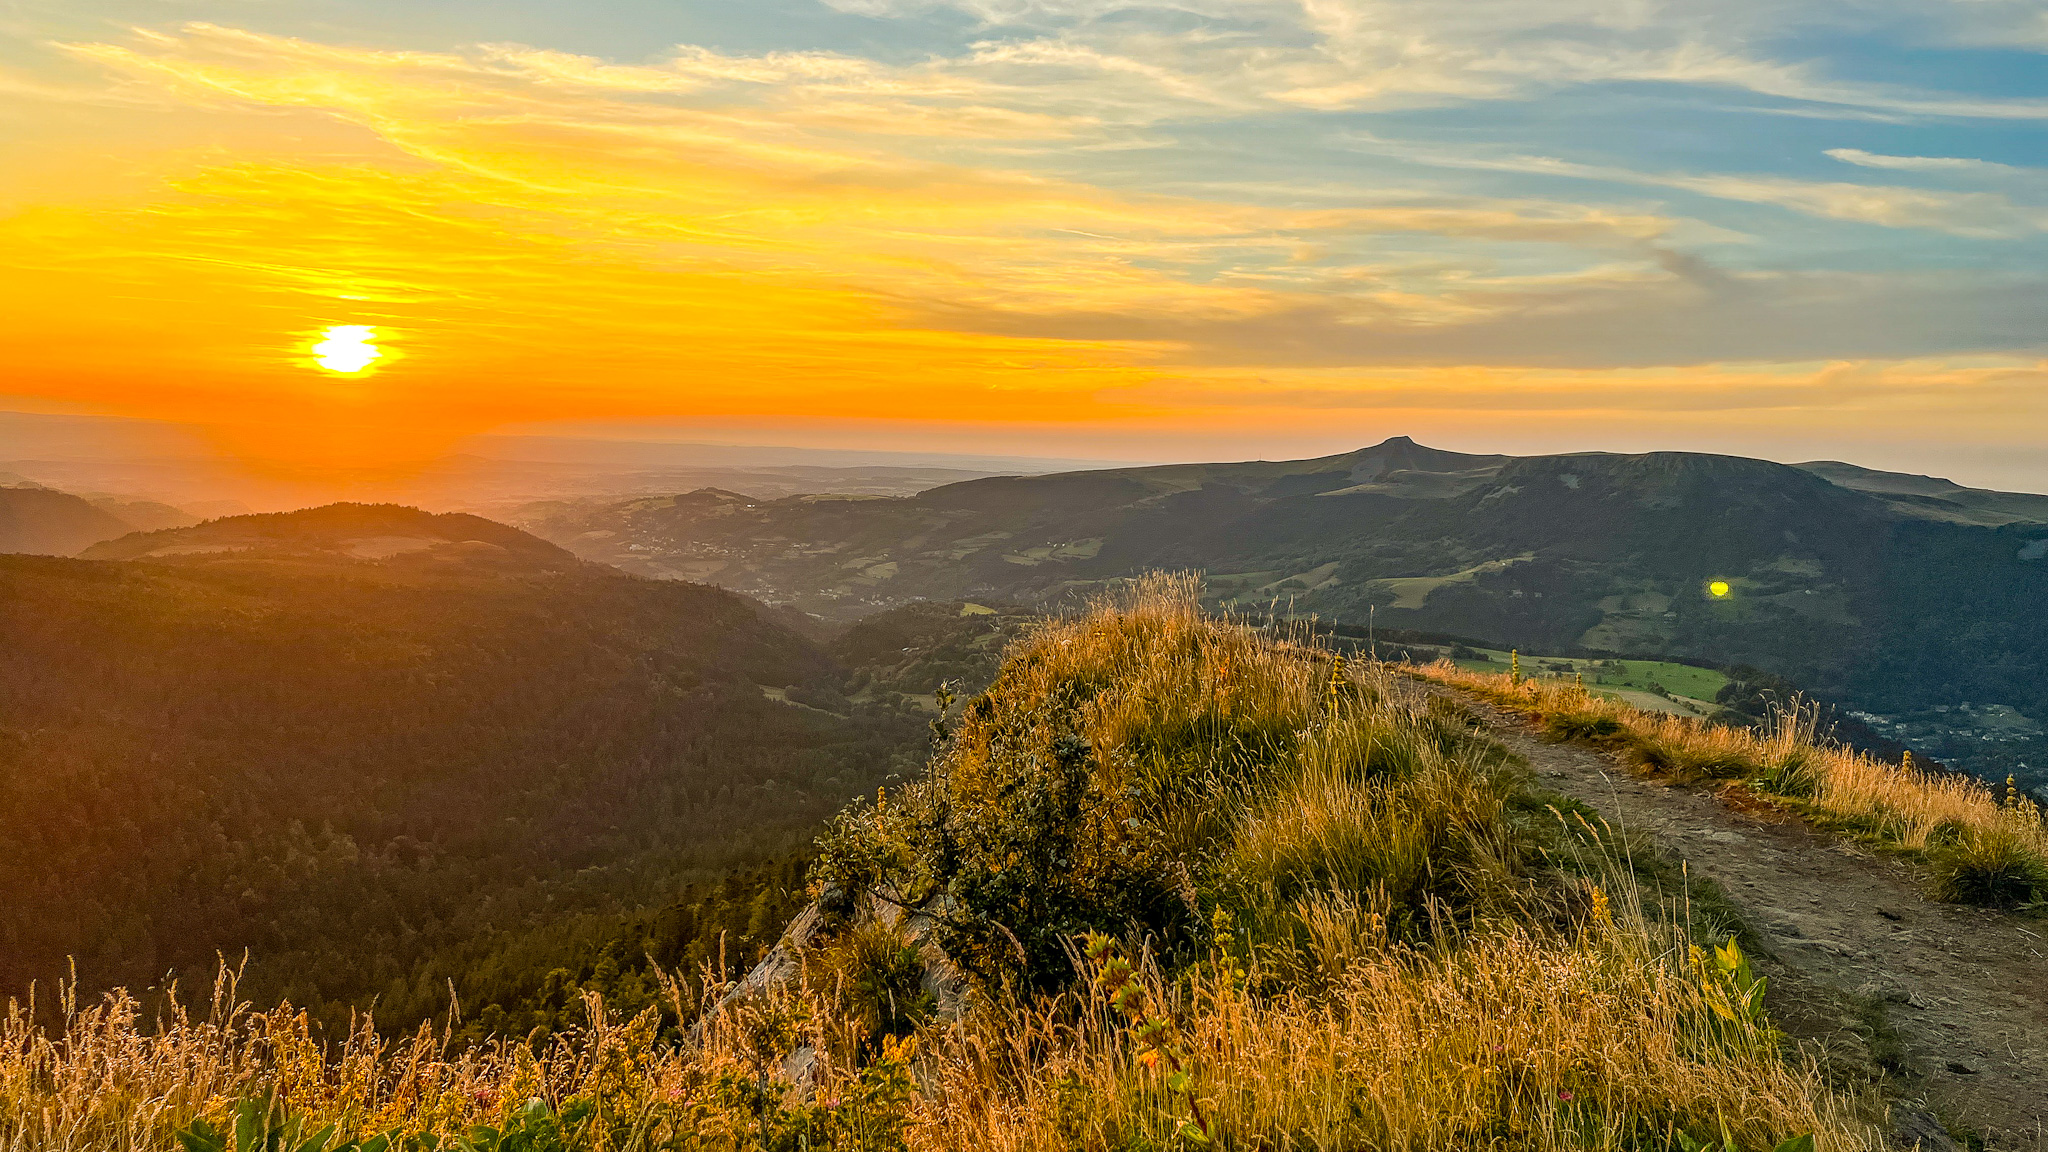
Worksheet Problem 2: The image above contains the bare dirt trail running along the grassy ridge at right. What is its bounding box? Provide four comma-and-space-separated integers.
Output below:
1430, 687, 2048, 1152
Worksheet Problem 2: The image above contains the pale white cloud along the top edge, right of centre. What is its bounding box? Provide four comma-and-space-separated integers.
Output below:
831, 0, 2048, 121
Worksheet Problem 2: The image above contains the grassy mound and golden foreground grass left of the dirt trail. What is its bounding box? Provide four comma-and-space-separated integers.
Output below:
0, 578, 1880, 1152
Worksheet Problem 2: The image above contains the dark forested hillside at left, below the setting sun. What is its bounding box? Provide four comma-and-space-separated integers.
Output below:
0, 506, 924, 1023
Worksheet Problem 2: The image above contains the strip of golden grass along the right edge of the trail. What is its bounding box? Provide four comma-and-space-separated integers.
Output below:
1415, 662, 2048, 906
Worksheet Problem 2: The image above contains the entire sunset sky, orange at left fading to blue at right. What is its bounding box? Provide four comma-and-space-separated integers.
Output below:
0, 0, 2048, 490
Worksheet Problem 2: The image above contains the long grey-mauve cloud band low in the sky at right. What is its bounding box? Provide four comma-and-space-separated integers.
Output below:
909, 256, 2048, 369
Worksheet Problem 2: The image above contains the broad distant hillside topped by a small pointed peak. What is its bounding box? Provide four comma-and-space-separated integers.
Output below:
516, 439, 2048, 781
